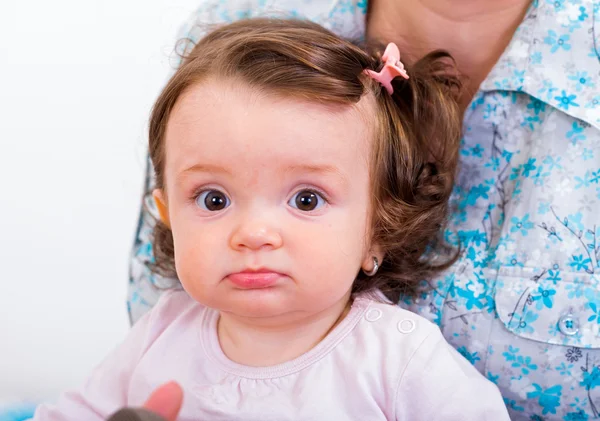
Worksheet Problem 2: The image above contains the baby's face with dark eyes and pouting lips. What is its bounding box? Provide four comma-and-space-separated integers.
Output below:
157, 81, 372, 318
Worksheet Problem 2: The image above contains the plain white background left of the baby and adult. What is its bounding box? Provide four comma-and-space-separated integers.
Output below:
0, 0, 201, 401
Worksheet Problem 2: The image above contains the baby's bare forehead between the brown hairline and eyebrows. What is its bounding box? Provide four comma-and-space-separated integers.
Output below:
165, 79, 372, 175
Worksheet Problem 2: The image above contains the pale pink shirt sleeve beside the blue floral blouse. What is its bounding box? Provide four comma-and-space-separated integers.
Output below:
395, 328, 510, 421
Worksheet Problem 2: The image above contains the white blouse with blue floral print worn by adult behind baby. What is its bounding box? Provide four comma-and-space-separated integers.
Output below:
128, 0, 600, 421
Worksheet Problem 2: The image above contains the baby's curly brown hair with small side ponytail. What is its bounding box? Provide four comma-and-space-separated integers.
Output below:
144, 19, 461, 302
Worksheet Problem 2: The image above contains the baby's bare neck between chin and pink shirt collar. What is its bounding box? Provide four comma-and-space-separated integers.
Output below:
217, 296, 351, 367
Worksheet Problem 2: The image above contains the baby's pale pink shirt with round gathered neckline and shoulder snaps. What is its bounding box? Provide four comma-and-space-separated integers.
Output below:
34, 291, 509, 421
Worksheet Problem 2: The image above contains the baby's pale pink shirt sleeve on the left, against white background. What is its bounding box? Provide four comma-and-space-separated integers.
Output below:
31, 294, 176, 421
